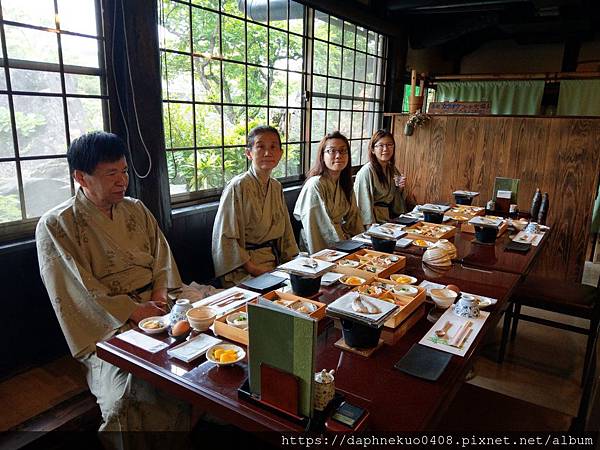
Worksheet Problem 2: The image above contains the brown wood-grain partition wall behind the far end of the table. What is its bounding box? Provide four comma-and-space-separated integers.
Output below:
394, 115, 600, 281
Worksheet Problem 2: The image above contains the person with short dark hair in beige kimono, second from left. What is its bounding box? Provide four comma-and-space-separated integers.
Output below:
212, 126, 298, 287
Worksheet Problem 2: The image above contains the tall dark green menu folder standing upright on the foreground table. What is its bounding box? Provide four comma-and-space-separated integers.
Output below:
248, 298, 317, 417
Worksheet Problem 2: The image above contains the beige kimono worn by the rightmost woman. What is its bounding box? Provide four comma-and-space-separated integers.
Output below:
354, 162, 406, 224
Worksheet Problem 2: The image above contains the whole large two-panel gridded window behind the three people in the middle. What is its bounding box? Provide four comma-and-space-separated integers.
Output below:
158, 0, 386, 202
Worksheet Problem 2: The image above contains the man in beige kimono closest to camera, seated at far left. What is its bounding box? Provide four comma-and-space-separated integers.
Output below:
36, 132, 190, 447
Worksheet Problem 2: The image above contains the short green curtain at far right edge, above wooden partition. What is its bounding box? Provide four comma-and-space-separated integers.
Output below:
556, 80, 600, 116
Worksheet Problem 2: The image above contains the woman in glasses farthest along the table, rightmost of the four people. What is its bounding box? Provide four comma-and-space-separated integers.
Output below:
354, 130, 406, 225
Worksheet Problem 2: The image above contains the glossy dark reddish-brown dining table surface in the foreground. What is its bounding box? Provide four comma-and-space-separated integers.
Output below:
97, 239, 537, 432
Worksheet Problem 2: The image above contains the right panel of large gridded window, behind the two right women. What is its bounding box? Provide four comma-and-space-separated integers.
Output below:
310, 11, 387, 166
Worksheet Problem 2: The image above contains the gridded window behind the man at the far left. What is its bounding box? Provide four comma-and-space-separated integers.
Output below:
0, 0, 108, 225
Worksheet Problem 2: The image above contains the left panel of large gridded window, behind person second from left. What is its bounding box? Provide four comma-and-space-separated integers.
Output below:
159, 0, 305, 200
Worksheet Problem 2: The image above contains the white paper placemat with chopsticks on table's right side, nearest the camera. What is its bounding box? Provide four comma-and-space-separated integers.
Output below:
419, 306, 490, 356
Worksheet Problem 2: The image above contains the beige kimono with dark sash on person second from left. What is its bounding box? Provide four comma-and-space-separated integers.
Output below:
212, 166, 298, 287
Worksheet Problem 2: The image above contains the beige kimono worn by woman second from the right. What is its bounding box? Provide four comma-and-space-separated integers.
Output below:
294, 175, 364, 253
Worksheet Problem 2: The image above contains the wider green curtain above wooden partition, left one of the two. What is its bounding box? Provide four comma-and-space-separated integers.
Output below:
436, 80, 544, 115
